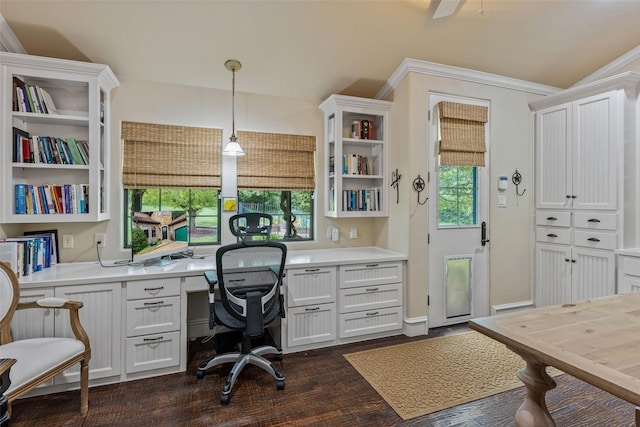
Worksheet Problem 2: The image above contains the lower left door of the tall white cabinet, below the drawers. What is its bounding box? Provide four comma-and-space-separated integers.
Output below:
535, 243, 572, 307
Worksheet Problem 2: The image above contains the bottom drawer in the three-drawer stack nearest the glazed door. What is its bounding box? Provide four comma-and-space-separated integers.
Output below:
340, 307, 402, 338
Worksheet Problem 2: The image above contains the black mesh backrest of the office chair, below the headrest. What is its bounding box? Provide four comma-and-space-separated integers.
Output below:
216, 240, 287, 321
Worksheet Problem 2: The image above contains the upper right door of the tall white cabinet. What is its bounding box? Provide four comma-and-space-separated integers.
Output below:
572, 91, 623, 209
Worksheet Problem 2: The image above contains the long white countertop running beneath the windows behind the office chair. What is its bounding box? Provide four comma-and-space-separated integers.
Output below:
19, 247, 407, 288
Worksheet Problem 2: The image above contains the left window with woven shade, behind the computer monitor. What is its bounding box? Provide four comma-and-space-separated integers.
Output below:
122, 122, 222, 247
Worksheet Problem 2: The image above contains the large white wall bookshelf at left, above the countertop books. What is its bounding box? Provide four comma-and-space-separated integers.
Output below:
0, 52, 119, 223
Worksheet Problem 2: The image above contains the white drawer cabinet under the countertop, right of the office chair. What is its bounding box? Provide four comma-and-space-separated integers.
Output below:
283, 262, 404, 352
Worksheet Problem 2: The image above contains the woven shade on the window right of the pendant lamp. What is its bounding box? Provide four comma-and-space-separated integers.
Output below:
238, 131, 316, 191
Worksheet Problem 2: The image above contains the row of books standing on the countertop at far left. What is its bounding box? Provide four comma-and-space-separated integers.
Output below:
0, 232, 58, 277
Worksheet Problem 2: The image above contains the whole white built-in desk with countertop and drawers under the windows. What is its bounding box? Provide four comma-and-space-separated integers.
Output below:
14, 247, 406, 393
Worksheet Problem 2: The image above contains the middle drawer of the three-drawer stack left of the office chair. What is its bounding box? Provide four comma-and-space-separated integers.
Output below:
127, 297, 180, 337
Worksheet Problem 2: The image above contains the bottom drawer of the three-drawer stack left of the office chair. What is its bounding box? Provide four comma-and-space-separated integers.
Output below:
126, 331, 180, 374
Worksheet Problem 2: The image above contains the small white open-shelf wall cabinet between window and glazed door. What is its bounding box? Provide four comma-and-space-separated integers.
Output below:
320, 95, 392, 218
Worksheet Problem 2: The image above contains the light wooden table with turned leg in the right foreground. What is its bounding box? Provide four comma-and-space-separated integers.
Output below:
469, 294, 640, 427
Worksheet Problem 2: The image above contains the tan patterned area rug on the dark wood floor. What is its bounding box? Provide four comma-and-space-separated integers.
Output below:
344, 331, 561, 420
